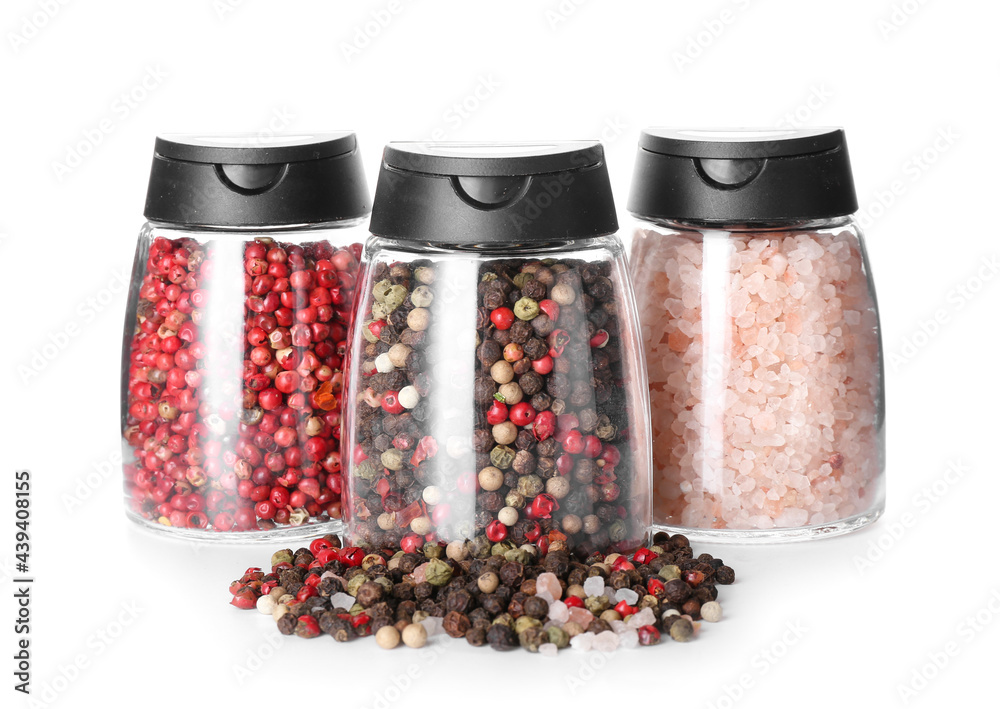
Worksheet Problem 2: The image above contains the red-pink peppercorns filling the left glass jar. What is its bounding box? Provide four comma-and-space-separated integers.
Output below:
123, 237, 361, 531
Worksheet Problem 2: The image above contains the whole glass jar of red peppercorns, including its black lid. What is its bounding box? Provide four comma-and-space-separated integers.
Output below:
121, 133, 369, 541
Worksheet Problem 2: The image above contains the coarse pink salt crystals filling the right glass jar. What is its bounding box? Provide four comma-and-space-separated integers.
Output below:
630, 228, 881, 529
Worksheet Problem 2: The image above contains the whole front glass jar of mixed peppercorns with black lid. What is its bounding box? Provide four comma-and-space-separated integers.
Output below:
344, 142, 650, 556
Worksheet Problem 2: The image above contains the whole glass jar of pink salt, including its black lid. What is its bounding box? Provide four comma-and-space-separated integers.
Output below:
628, 129, 885, 541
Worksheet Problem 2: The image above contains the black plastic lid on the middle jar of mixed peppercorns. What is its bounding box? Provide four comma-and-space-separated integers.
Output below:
371, 141, 618, 245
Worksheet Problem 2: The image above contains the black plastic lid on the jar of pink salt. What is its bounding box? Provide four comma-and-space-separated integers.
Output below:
628, 128, 858, 222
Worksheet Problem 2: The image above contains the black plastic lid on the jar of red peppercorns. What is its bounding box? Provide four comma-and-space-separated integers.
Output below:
143, 131, 370, 227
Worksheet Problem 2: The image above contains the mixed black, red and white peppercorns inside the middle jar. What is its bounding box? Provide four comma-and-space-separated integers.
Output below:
345, 259, 645, 557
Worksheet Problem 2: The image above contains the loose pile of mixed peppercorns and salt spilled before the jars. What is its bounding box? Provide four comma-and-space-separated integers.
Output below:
230, 533, 735, 655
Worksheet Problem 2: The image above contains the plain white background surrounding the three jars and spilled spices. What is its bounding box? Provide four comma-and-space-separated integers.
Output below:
0, 0, 1000, 709
